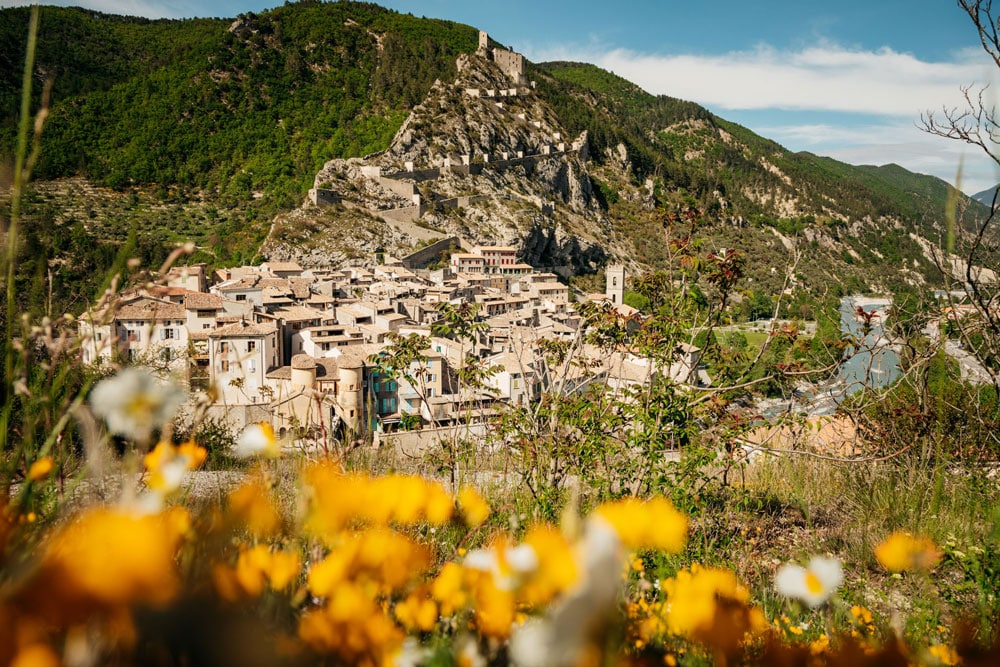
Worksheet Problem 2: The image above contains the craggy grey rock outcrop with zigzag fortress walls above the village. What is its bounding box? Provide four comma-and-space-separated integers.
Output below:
261, 47, 613, 273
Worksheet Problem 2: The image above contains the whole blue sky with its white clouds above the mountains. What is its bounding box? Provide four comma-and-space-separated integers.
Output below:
0, 0, 1000, 193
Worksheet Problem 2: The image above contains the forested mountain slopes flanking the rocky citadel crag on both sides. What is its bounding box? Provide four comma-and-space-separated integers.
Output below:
0, 1, 984, 314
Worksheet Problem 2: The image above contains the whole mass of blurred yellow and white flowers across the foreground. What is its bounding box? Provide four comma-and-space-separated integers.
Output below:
0, 368, 996, 667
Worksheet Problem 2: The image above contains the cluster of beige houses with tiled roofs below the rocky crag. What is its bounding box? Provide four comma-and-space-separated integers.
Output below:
79, 246, 707, 452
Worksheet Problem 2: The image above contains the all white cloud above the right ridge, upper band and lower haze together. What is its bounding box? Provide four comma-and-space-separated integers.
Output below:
531, 40, 1000, 193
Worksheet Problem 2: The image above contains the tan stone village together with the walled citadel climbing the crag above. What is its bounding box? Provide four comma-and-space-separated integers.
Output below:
72, 32, 707, 454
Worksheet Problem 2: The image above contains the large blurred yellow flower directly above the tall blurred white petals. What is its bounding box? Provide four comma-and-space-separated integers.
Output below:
595, 498, 687, 553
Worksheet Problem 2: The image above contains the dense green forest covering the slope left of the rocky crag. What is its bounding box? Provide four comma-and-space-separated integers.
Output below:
0, 2, 475, 208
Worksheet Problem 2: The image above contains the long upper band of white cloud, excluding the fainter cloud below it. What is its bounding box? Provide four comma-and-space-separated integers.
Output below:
537, 43, 996, 117
